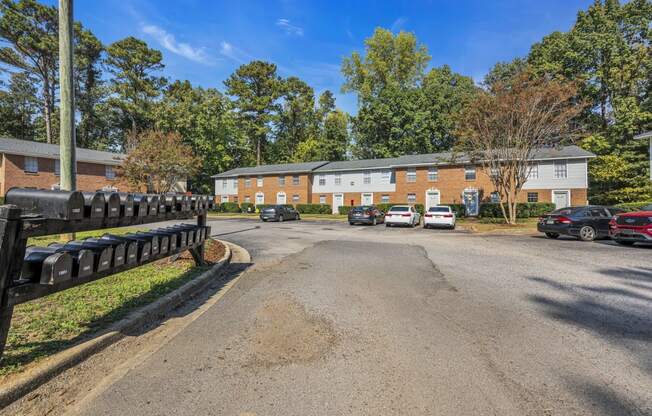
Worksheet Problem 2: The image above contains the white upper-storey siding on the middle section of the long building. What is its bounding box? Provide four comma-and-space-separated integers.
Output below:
312, 169, 396, 193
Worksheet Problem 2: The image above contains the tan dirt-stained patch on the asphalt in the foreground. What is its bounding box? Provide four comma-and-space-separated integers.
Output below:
244, 294, 338, 367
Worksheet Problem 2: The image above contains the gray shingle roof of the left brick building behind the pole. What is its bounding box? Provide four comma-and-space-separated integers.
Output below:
0, 137, 126, 165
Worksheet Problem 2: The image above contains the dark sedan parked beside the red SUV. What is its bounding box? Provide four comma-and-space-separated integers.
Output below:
537, 205, 625, 241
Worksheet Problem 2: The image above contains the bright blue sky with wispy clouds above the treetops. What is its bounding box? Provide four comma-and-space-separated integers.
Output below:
58, 0, 591, 113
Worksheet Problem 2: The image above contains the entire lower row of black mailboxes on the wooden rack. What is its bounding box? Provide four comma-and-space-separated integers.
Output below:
20, 224, 210, 285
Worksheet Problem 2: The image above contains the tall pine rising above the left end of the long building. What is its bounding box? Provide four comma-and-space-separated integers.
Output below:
224, 61, 282, 165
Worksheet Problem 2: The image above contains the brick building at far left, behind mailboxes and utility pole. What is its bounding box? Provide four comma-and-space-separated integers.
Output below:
0, 138, 185, 197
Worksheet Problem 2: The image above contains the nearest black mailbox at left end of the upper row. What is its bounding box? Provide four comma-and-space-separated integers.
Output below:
5, 188, 84, 220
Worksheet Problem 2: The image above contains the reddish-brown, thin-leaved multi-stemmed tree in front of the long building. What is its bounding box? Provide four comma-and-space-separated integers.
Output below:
459, 72, 583, 224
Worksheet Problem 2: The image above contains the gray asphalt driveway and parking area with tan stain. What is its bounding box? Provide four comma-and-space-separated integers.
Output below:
52, 220, 652, 415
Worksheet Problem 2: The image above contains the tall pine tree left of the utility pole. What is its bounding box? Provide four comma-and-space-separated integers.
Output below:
0, 0, 59, 143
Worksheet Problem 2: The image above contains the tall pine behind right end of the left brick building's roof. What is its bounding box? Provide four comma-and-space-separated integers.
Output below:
106, 36, 165, 149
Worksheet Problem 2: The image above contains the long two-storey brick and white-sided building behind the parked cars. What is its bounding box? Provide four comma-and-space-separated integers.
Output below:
213, 146, 595, 214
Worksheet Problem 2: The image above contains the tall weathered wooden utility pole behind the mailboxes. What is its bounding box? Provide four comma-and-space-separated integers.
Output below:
59, 0, 77, 191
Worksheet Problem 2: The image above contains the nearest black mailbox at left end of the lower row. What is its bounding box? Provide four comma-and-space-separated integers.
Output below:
21, 246, 72, 285
